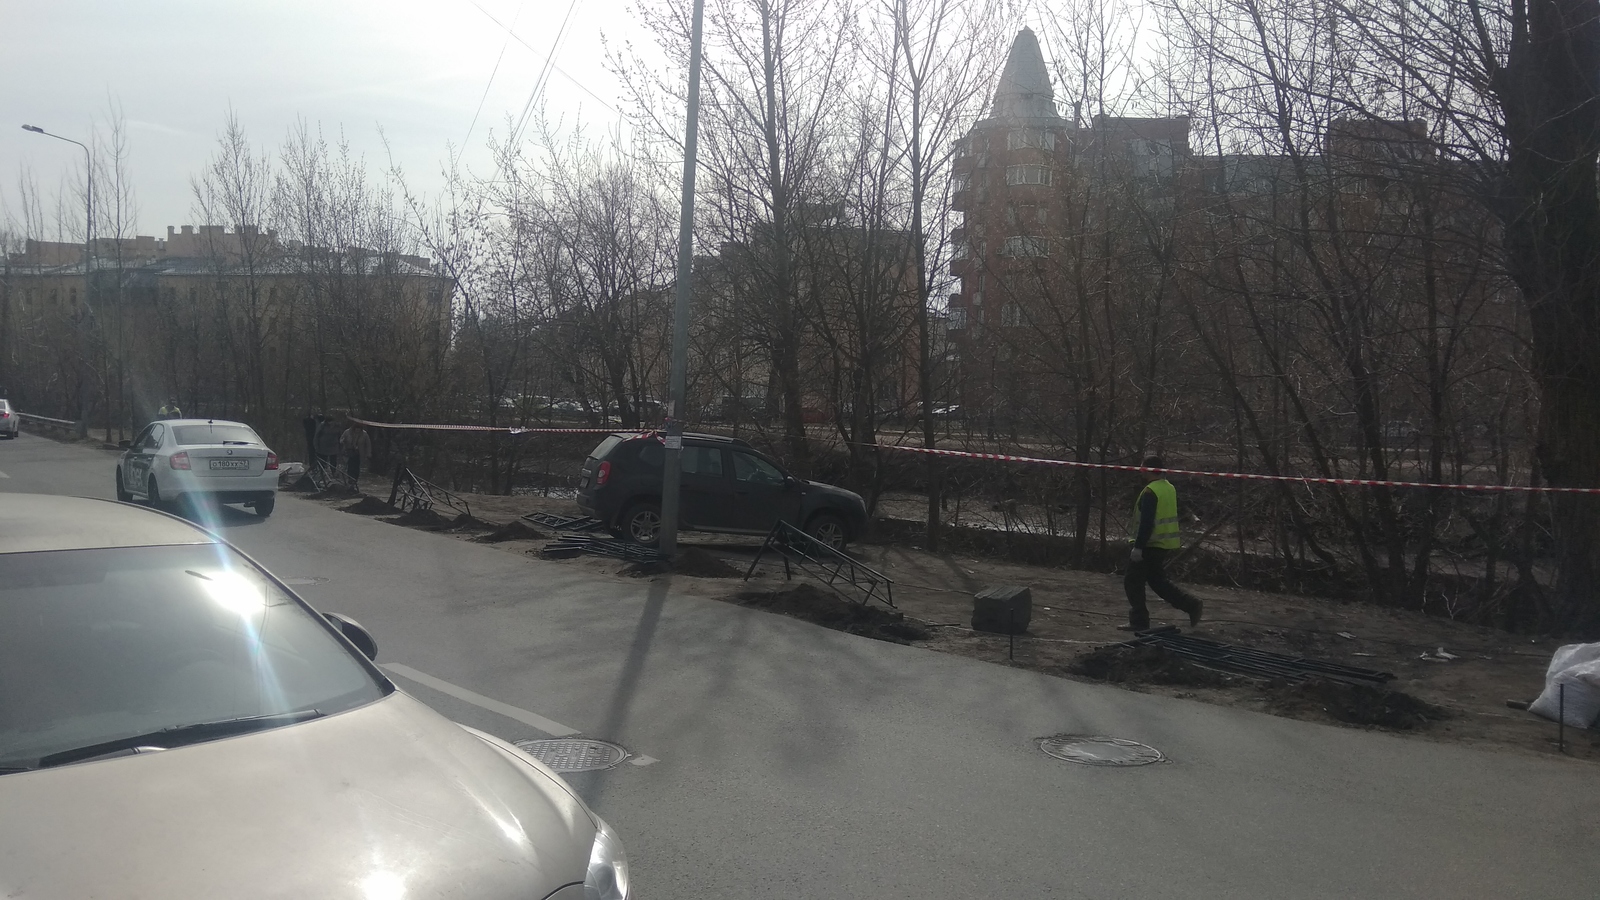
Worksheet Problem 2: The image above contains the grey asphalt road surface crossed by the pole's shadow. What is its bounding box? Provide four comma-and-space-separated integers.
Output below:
0, 436, 1600, 900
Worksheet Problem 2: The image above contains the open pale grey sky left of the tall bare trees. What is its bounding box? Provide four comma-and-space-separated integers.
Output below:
0, 0, 630, 235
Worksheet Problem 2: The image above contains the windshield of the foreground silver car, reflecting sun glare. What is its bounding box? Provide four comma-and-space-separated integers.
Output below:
0, 544, 390, 762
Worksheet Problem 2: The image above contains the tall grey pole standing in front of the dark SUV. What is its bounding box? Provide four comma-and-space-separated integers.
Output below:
659, 0, 706, 559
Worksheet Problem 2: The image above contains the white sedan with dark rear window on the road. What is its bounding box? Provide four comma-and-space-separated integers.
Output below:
117, 418, 278, 519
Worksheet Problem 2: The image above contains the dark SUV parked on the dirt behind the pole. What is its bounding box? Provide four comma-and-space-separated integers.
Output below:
578, 434, 867, 548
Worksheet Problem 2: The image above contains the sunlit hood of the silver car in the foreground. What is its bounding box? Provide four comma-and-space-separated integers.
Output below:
0, 692, 595, 900
